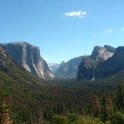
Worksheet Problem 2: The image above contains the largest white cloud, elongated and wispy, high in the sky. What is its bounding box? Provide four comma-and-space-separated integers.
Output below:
65, 11, 87, 18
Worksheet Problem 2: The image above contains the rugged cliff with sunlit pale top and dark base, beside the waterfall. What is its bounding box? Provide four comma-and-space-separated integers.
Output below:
77, 45, 116, 80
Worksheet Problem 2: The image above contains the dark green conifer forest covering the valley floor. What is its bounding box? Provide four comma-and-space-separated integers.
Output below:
1, 70, 124, 124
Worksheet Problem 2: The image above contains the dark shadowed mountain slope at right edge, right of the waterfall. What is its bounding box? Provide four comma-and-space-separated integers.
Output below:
95, 47, 124, 78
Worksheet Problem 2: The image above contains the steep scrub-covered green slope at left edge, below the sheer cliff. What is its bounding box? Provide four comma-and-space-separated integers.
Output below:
0, 45, 48, 86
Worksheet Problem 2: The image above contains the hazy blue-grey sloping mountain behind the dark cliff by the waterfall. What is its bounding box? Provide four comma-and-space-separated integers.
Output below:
55, 56, 83, 79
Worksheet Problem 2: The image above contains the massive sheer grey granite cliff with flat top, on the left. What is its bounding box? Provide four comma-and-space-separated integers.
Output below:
3, 42, 54, 79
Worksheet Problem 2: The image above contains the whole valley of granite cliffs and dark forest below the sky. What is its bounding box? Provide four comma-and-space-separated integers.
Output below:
0, 42, 124, 124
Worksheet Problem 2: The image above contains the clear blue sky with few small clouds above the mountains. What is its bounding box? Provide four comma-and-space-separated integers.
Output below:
0, 0, 124, 62
